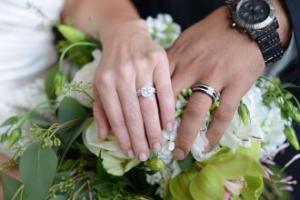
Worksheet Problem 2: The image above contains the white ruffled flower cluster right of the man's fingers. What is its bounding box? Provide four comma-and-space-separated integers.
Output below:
191, 86, 287, 161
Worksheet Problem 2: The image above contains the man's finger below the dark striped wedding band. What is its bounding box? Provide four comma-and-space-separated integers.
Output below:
173, 92, 212, 160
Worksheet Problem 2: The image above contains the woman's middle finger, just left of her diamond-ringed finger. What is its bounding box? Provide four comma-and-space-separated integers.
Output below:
118, 75, 149, 161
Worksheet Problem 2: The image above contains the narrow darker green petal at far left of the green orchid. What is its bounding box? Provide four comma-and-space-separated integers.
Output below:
169, 170, 198, 200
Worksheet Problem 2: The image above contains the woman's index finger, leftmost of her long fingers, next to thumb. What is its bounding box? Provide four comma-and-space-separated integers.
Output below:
98, 87, 134, 157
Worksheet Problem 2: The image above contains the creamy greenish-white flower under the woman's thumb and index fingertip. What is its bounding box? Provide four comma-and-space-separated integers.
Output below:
83, 119, 140, 176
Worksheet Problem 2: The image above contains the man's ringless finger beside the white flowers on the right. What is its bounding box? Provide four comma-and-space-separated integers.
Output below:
207, 87, 241, 151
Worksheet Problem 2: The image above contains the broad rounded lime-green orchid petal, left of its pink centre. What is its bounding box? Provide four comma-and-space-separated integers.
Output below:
189, 165, 224, 200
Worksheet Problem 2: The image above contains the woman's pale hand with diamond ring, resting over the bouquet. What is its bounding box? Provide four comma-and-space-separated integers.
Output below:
94, 20, 175, 161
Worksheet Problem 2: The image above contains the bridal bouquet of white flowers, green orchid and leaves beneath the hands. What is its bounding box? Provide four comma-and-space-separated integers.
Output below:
0, 15, 300, 200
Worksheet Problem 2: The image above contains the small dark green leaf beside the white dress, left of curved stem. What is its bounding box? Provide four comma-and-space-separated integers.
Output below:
45, 65, 59, 100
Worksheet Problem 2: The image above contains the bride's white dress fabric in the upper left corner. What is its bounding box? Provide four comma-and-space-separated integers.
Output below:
0, 0, 64, 156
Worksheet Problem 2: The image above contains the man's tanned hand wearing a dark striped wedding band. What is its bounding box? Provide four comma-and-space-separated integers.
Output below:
168, 2, 288, 159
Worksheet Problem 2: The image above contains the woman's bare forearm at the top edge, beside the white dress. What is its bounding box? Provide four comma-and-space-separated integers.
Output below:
62, 0, 140, 38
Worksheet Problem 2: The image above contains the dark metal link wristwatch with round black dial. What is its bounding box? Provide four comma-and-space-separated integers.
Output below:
226, 0, 284, 66
